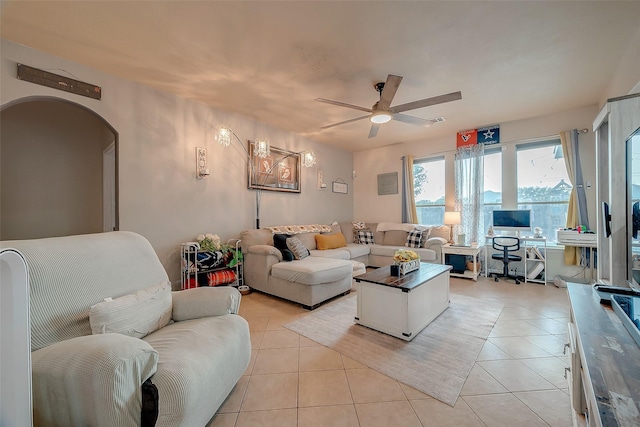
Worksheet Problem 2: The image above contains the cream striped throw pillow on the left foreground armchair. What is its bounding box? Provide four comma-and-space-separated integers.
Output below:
89, 282, 172, 338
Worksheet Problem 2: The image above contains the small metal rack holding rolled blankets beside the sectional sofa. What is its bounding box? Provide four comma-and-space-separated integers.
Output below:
180, 239, 244, 289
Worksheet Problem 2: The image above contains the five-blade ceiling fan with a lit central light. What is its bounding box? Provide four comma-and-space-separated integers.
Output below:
316, 74, 462, 138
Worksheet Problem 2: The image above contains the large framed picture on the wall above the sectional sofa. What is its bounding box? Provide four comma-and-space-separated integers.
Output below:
248, 142, 300, 193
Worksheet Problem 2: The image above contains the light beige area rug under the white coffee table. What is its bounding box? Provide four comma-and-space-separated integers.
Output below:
285, 294, 503, 406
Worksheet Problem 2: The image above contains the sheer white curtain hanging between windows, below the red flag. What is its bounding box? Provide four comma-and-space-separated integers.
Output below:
455, 144, 484, 242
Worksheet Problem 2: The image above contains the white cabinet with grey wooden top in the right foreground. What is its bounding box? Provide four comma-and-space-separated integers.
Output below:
565, 283, 640, 427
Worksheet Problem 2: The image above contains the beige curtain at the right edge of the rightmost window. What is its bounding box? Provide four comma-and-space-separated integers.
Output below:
560, 129, 589, 265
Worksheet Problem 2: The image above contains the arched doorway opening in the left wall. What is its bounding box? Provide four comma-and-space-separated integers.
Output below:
0, 97, 118, 240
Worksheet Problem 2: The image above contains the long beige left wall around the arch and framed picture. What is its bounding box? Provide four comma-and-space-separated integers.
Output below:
0, 40, 353, 281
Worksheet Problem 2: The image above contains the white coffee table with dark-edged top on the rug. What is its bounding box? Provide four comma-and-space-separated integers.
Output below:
355, 262, 451, 341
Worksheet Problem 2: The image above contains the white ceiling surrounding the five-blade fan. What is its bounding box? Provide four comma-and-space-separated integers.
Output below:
0, 0, 640, 151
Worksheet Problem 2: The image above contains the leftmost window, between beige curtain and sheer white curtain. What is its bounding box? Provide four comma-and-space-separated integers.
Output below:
413, 156, 445, 225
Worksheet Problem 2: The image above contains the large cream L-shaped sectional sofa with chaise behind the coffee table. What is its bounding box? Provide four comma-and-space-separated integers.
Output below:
240, 222, 449, 309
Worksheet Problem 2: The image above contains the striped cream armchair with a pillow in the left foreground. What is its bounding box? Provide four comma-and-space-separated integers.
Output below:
0, 231, 251, 427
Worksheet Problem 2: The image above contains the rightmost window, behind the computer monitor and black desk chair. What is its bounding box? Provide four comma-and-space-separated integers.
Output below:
516, 139, 573, 239
